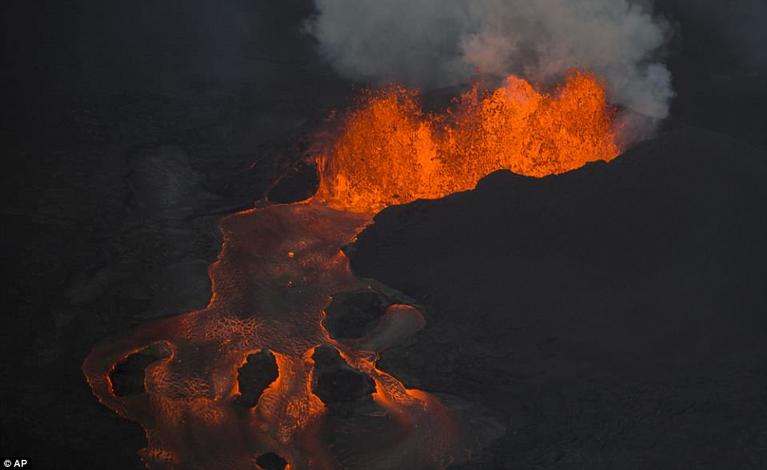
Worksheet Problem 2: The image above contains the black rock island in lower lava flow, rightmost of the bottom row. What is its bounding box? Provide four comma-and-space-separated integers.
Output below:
312, 346, 375, 405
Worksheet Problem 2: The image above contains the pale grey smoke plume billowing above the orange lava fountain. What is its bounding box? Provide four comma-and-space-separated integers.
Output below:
309, 0, 673, 139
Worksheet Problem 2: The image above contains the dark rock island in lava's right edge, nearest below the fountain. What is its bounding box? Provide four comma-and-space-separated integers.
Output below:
323, 290, 391, 339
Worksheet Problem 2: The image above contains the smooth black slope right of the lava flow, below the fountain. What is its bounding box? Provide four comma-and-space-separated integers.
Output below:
351, 128, 767, 468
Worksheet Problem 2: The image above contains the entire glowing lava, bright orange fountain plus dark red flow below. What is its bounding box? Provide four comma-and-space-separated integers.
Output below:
83, 71, 619, 470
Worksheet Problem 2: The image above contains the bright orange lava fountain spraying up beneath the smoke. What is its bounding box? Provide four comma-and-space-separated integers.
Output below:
316, 71, 619, 212
